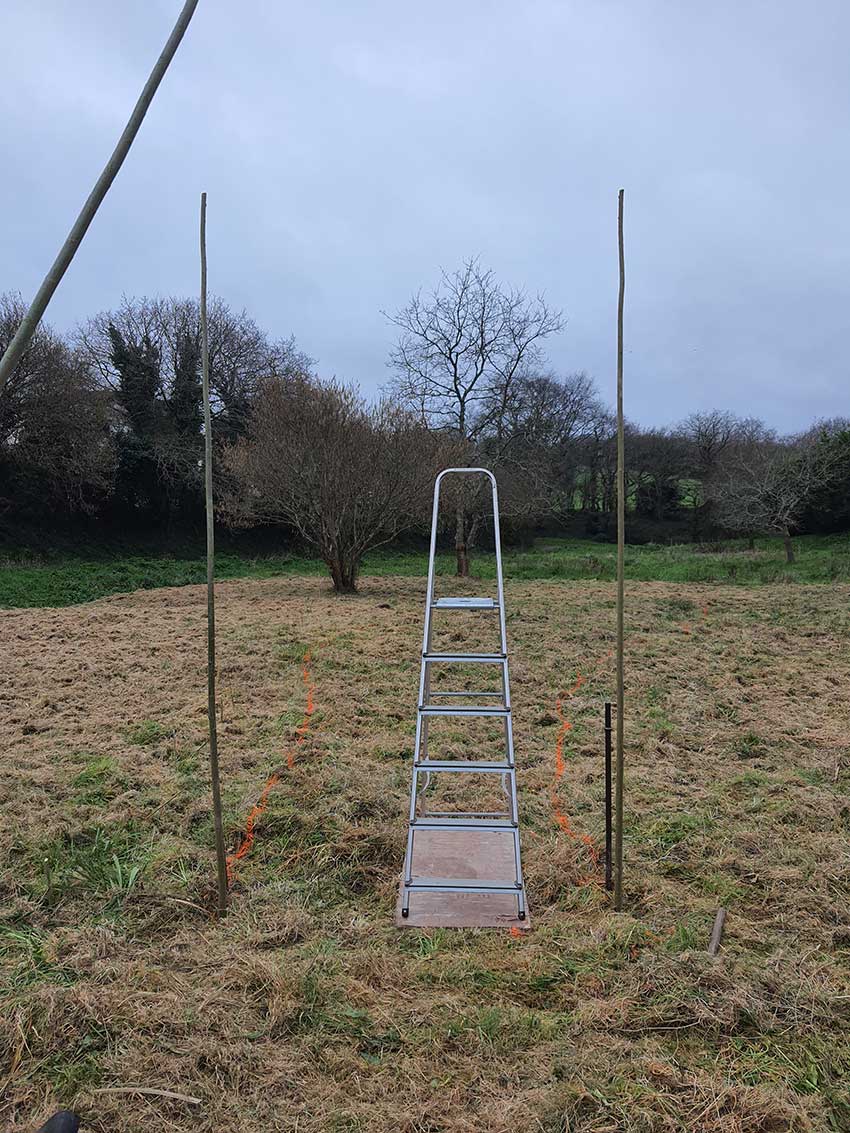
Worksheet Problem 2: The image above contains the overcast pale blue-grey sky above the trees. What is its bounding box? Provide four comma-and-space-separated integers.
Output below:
0, 0, 850, 431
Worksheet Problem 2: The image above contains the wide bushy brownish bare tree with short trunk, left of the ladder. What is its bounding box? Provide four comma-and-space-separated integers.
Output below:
221, 378, 455, 594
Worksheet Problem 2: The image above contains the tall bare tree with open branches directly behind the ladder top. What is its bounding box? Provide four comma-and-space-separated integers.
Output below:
388, 258, 563, 577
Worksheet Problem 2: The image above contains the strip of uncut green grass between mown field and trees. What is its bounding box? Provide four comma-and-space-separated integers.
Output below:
0, 535, 850, 608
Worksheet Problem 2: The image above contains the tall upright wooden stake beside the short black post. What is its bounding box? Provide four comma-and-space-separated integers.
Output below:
614, 189, 626, 912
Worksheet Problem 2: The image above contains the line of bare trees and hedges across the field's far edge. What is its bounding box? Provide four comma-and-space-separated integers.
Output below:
0, 259, 850, 590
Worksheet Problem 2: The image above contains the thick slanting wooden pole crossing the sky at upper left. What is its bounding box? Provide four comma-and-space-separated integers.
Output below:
0, 0, 198, 393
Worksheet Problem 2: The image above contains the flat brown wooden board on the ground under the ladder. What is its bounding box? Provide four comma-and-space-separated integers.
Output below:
396, 829, 530, 932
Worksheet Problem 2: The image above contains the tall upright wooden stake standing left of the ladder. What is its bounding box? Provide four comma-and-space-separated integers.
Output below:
201, 193, 228, 917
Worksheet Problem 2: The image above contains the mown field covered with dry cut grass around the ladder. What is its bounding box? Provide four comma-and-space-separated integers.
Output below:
0, 571, 850, 1133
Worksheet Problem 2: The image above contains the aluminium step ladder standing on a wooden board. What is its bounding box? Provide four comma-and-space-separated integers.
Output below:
399, 468, 527, 926
